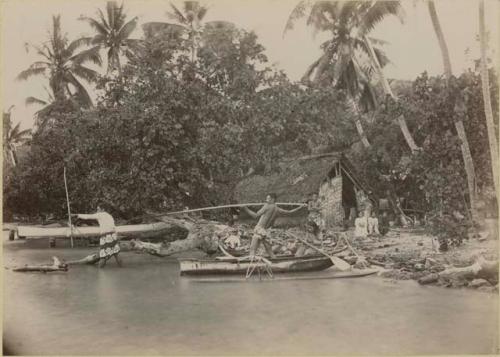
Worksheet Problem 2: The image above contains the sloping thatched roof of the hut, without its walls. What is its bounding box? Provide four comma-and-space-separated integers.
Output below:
235, 153, 367, 202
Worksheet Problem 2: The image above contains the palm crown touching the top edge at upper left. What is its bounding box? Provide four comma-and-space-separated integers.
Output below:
80, 1, 139, 74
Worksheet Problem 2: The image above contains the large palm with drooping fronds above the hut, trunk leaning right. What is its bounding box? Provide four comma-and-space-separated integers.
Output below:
285, 1, 418, 152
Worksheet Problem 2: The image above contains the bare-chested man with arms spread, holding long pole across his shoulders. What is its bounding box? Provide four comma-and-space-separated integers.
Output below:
243, 193, 306, 258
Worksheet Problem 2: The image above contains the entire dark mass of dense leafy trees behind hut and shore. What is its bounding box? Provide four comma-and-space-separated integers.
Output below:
3, 2, 498, 250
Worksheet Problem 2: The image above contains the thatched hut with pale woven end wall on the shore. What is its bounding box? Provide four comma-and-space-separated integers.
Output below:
235, 153, 372, 228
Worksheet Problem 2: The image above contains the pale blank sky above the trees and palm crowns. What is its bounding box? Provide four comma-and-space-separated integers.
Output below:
0, 0, 500, 129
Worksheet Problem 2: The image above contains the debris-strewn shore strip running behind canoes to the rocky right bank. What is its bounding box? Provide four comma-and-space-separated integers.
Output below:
4, 225, 498, 293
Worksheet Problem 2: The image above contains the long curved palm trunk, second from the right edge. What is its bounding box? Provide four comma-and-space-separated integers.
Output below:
427, 0, 477, 219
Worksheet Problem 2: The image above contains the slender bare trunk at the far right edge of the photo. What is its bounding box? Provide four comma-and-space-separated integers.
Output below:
479, 0, 500, 200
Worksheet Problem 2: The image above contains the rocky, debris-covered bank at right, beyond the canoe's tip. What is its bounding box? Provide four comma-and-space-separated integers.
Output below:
346, 229, 498, 293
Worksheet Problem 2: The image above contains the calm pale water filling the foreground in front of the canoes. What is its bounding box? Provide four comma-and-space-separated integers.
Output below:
3, 236, 498, 355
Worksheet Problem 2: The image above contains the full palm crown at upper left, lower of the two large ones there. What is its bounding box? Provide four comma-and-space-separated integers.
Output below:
17, 15, 101, 106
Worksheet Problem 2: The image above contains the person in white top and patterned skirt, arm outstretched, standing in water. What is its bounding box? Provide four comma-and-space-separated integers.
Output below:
75, 205, 122, 268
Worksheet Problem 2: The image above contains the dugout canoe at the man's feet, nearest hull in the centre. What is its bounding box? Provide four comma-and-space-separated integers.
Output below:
178, 256, 332, 275
